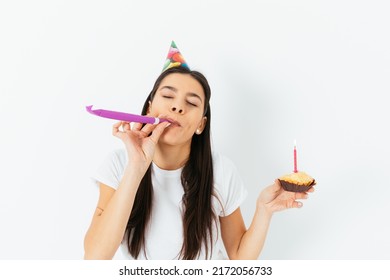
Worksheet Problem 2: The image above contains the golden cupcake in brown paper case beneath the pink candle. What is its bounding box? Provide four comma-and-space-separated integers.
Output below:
278, 171, 316, 192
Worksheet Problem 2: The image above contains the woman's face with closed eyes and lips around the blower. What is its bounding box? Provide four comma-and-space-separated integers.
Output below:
148, 73, 207, 145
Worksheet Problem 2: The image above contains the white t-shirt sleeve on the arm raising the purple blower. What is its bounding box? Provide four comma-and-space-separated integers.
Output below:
91, 149, 127, 189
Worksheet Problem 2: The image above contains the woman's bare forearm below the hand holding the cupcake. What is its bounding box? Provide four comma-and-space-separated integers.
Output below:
237, 205, 272, 260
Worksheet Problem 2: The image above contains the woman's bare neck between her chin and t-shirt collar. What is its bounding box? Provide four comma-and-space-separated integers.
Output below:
153, 141, 191, 170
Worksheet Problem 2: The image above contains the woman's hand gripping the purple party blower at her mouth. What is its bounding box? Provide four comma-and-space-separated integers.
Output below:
112, 122, 171, 175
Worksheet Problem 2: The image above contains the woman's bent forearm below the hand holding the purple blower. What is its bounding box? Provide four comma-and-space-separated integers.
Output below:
84, 165, 142, 259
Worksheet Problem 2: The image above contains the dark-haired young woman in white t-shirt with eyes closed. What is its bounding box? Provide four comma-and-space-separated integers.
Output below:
84, 46, 313, 259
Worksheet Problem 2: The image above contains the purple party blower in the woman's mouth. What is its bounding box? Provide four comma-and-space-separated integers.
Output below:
86, 105, 170, 124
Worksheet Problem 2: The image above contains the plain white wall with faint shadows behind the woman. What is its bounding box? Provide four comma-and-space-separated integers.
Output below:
0, 0, 390, 259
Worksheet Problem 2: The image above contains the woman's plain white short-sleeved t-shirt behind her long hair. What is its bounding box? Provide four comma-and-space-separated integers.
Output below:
93, 149, 247, 260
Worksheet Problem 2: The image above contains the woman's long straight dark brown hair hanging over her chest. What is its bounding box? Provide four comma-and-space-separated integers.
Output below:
125, 67, 217, 260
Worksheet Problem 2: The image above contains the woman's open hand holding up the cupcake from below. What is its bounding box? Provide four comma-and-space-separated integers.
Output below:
257, 180, 314, 214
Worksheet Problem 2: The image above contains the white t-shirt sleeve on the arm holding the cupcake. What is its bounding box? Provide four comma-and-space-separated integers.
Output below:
214, 153, 248, 217
